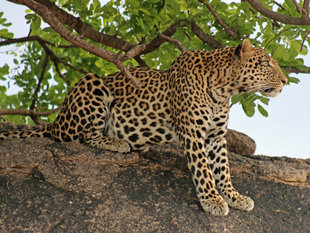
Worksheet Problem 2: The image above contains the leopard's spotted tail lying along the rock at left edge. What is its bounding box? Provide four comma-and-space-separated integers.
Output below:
0, 124, 52, 141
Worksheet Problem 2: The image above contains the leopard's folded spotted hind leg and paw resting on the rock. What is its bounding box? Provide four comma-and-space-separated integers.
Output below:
52, 74, 130, 152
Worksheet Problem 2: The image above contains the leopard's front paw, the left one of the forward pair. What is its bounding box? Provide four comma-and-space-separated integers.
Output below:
200, 196, 229, 216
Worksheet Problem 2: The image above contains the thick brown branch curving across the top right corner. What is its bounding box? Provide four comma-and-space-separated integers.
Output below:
245, 0, 310, 25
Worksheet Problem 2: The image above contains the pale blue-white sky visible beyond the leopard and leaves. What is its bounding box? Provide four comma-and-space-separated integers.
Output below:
0, 1, 310, 158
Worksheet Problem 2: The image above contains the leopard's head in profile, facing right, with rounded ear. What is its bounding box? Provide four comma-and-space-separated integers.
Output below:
234, 39, 287, 97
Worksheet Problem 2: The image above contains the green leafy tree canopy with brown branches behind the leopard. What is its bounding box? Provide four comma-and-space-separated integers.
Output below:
0, 0, 310, 123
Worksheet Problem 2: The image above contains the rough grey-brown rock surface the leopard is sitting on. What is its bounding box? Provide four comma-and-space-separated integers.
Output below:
0, 123, 310, 233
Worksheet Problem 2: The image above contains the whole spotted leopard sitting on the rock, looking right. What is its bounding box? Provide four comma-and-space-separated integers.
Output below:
0, 39, 288, 216
